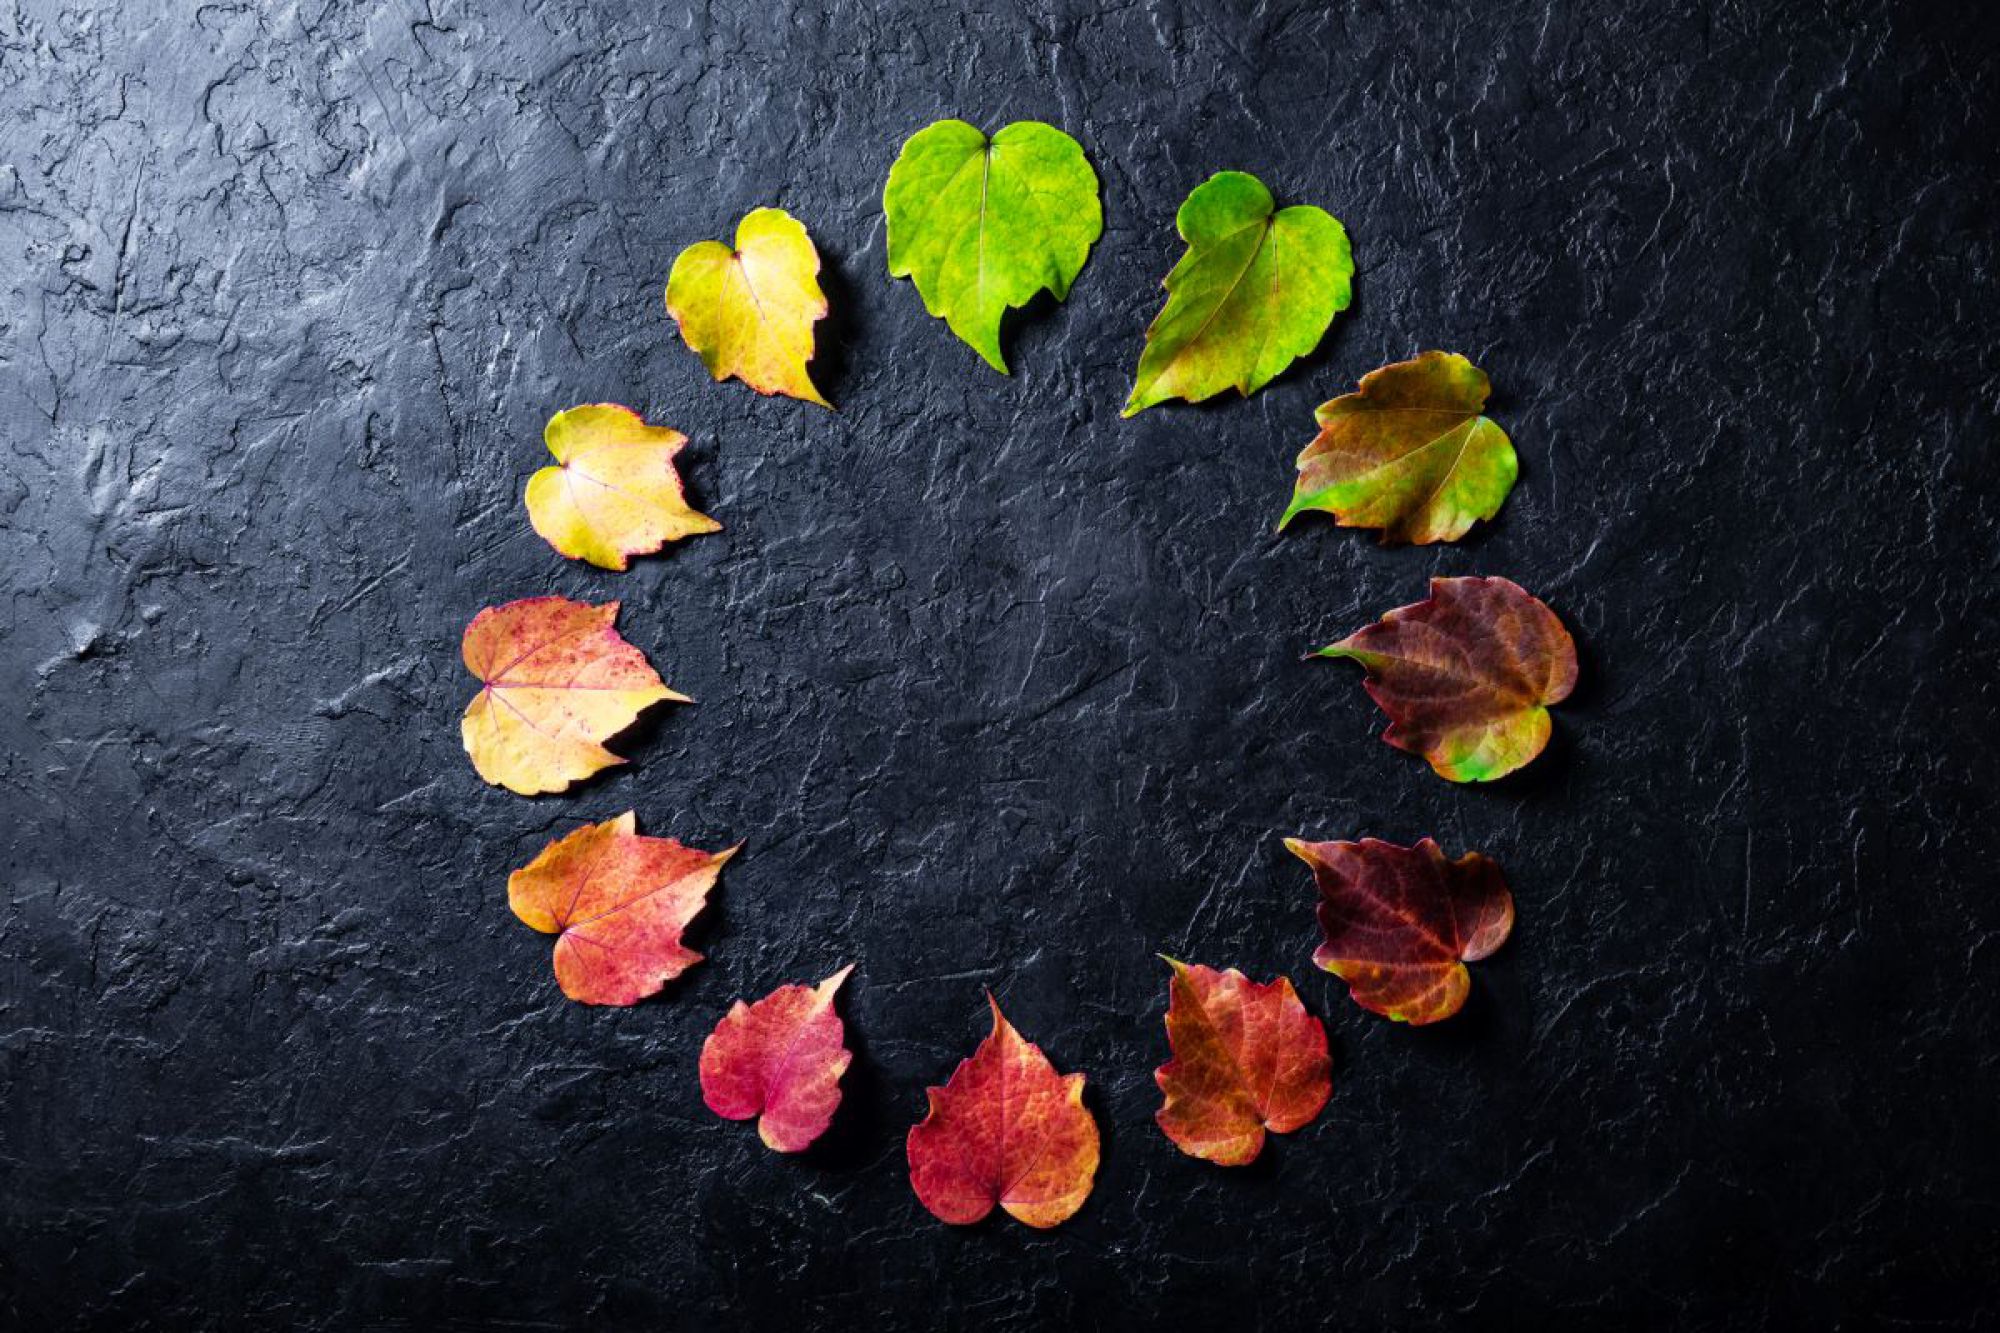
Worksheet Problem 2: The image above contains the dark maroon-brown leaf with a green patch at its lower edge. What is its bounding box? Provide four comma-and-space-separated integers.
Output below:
1318, 578, 1576, 783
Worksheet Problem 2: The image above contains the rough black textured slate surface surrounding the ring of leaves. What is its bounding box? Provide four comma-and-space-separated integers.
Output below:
0, 0, 2000, 1329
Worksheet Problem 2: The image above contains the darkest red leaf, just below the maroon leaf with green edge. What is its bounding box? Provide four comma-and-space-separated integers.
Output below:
1284, 839, 1514, 1025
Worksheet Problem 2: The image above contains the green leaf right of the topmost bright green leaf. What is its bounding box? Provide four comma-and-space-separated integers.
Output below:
1124, 172, 1354, 416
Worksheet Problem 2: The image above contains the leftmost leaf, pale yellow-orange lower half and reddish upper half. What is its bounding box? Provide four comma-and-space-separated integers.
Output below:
458, 596, 690, 797
